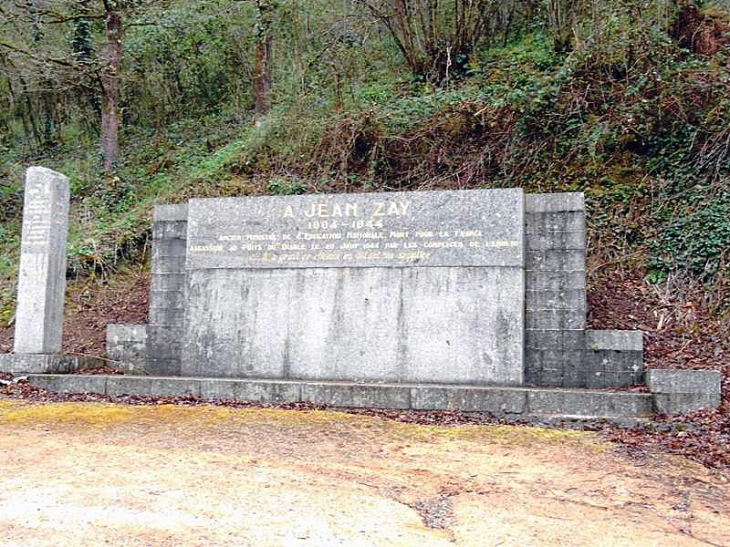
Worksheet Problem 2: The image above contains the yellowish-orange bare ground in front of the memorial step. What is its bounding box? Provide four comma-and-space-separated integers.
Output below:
0, 398, 730, 547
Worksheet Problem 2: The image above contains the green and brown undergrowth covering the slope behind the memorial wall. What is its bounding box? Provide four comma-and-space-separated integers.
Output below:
0, 9, 730, 321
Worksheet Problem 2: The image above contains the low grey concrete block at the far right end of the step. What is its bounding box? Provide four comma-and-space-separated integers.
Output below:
646, 369, 722, 414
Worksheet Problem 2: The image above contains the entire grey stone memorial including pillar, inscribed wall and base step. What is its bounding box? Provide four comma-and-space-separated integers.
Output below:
0, 168, 721, 420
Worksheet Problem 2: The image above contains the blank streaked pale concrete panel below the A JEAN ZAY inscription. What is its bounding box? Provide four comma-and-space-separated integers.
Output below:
182, 268, 524, 385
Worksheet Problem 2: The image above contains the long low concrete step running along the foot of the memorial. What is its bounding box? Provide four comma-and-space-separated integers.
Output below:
28, 374, 653, 421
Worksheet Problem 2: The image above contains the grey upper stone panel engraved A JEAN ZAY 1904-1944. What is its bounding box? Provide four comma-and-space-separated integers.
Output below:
188, 190, 523, 269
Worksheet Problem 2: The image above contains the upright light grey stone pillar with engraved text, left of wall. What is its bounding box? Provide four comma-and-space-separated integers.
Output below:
15, 167, 69, 354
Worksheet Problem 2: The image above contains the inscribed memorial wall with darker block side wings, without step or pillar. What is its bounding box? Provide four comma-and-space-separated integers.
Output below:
134, 190, 643, 394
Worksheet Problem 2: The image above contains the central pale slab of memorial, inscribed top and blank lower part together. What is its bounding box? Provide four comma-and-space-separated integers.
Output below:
181, 189, 525, 385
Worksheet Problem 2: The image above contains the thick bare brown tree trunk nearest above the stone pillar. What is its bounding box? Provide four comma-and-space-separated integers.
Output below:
101, 8, 122, 174
